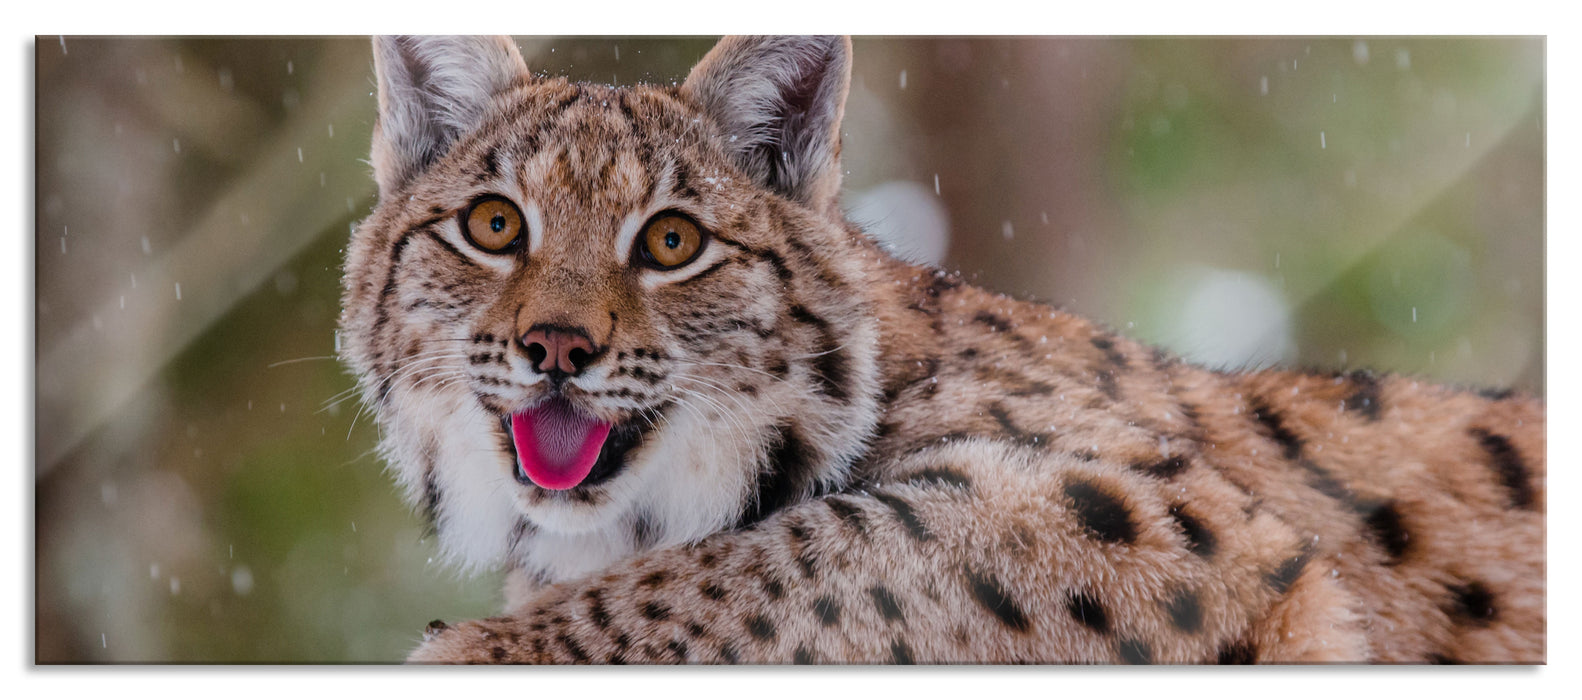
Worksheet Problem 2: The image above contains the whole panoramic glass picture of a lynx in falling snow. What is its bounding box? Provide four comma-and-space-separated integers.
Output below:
32, 36, 1549, 665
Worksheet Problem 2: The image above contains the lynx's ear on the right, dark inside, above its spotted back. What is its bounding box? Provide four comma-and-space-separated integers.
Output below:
682, 36, 851, 211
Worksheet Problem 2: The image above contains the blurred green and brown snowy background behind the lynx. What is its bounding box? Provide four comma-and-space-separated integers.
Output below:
33, 36, 1546, 664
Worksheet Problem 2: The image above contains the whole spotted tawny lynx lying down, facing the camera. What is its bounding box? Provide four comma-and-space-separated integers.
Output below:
342, 36, 1546, 664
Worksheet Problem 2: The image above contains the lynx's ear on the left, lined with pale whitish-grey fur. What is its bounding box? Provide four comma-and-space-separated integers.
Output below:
370, 36, 530, 198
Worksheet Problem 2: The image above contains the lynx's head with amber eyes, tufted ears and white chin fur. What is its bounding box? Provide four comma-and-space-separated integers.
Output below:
342, 38, 880, 578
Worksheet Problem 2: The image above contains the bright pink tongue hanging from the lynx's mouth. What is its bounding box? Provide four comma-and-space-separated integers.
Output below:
511, 399, 611, 491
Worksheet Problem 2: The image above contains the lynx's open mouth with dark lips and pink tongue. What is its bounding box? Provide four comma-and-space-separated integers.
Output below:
500, 396, 658, 491
